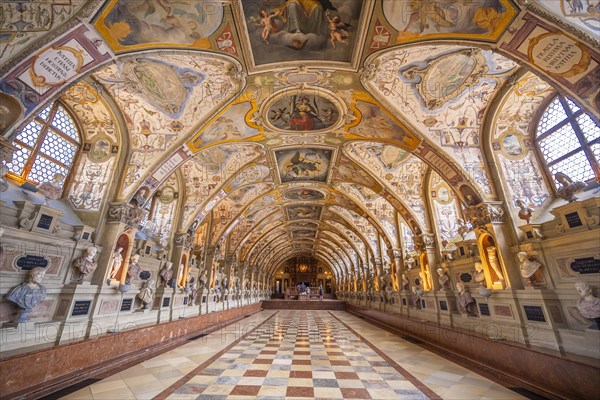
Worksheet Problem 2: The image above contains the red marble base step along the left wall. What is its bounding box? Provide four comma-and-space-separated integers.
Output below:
0, 303, 262, 399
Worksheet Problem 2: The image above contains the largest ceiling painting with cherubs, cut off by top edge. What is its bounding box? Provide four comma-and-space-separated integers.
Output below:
238, 0, 372, 71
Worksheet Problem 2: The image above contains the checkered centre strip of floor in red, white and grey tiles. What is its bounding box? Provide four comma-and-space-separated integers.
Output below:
168, 311, 429, 400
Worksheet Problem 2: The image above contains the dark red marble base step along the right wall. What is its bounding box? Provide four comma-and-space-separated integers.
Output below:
346, 304, 600, 399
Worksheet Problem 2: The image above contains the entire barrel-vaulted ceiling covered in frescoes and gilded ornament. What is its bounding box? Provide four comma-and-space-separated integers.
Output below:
0, 0, 600, 282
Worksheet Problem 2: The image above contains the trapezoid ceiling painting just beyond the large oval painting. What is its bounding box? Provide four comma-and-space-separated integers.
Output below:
274, 147, 333, 183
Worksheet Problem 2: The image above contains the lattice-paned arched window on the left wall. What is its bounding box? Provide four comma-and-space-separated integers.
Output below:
7, 102, 80, 191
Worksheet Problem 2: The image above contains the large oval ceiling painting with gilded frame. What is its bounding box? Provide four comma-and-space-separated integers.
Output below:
261, 89, 346, 133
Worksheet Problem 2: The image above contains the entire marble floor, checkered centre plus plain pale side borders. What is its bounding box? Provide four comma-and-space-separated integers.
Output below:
56, 310, 523, 400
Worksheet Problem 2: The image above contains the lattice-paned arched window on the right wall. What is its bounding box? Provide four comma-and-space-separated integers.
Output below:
535, 94, 600, 185
